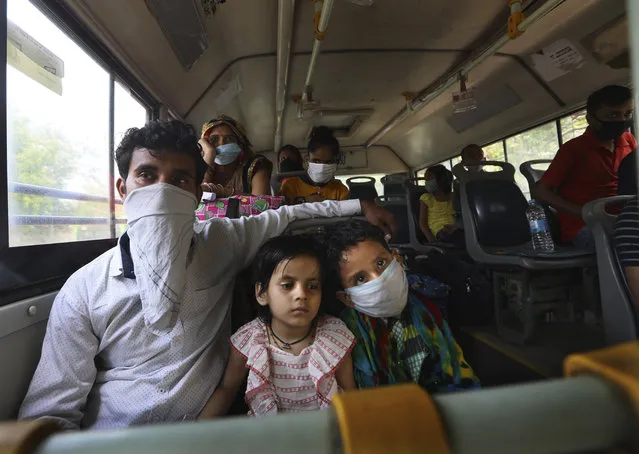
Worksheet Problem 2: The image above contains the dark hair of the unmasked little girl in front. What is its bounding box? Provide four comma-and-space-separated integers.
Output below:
253, 235, 324, 323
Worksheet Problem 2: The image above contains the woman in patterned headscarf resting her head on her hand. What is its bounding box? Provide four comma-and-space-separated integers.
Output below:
200, 115, 273, 197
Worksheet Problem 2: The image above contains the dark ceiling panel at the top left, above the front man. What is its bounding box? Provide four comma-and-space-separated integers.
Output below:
146, 0, 209, 69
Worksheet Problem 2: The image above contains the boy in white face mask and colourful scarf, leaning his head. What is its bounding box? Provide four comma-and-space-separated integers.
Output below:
325, 221, 480, 392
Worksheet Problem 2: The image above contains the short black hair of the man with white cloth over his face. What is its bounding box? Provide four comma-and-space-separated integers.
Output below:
115, 120, 208, 185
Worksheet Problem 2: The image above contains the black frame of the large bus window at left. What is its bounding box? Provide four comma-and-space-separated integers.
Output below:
0, 0, 160, 306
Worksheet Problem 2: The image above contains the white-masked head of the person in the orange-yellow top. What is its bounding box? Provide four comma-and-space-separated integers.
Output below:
308, 126, 340, 184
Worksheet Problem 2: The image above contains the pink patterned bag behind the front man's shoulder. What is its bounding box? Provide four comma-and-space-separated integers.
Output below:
195, 195, 285, 221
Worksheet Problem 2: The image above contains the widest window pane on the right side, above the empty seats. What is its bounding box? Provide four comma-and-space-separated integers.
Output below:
506, 121, 559, 198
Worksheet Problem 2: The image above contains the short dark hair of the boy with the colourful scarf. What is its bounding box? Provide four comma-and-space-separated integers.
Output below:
323, 219, 391, 292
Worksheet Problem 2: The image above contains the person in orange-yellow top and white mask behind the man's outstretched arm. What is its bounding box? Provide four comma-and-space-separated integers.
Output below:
280, 126, 350, 204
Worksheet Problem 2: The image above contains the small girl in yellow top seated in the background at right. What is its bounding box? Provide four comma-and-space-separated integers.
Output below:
419, 164, 461, 243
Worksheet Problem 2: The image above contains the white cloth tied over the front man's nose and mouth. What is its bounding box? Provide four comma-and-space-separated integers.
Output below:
124, 183, 197, 334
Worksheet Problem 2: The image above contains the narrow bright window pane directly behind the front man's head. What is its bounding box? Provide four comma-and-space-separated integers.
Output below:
113, 81, 148, 236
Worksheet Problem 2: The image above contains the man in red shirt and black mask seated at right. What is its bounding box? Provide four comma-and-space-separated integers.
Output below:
537, 85, 637, 250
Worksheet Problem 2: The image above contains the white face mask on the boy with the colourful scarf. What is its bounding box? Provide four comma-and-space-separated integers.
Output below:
344, 259, 408, 318
